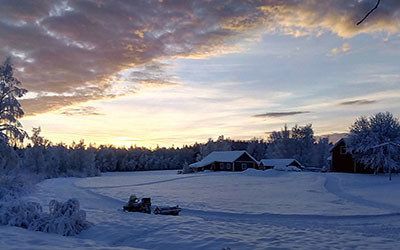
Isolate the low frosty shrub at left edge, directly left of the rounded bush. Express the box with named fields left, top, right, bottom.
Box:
left=0, top=200, right=42, bottom=228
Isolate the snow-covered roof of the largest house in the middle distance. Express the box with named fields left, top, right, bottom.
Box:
left=189, top=150, right=257, bottom=168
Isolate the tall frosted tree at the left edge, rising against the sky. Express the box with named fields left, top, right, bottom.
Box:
left=0, top=58, right=27, bottom=143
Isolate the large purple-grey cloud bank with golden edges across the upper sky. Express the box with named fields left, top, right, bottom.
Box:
left=0, top=0, right=400, bottom=114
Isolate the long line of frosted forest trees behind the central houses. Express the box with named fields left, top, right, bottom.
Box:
left=0, top=125, right=330, bottom=178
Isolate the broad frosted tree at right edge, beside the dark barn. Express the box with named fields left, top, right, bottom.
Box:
left=348, top=112, right=400, bottom=179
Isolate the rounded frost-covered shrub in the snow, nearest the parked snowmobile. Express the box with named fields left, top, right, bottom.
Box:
left=29, top=199, right=90, bottom=236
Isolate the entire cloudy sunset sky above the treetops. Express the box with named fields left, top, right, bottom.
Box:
left=0, top=0, right=400, bottom=147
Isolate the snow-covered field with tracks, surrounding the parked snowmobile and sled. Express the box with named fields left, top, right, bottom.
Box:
left=0, top=169, right=400, bottom=249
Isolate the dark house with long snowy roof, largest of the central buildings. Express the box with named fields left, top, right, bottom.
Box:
left=189, top=151, right=258, bottom=172
